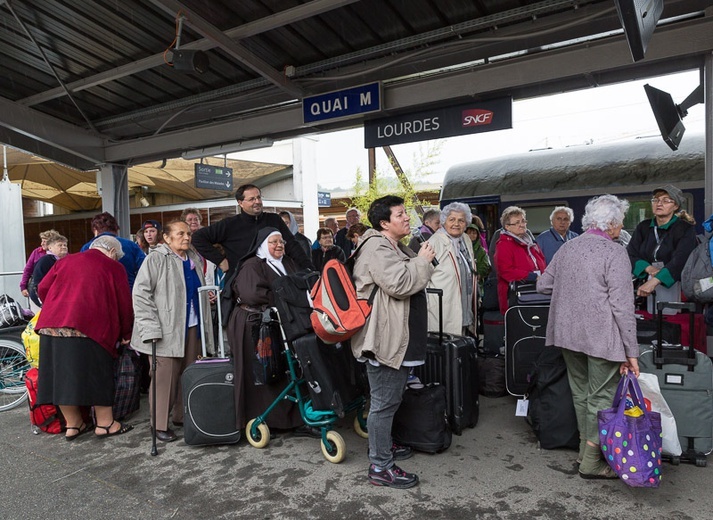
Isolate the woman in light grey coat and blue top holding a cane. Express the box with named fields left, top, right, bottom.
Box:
left=131, top=220, right=213, bottom=442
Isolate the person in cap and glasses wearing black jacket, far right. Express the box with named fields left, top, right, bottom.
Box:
left=627, top=184, right=697, bottom=297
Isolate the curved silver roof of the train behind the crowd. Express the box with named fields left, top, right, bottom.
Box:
left=441, top=133, right=705, bottom=201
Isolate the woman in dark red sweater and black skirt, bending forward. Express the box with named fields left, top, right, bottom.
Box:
left=36, top=235, right=134, bottom=441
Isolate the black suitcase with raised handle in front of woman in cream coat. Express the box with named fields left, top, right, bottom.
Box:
left=415, top=289, right=480, bottom=435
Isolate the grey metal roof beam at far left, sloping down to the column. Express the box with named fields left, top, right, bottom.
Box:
left=0, top=98, right=104, bottom=165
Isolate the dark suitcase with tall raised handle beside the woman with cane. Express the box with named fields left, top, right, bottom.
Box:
left=181, top=286, right=240, bottom=446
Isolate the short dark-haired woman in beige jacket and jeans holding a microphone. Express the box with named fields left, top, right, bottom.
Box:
left=352, top=195, right=435, bottom=489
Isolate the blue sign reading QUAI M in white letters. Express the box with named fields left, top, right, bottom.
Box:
left=302, top=81, right=381, bottom=123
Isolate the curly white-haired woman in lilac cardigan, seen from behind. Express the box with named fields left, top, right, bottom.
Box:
left=537, top=195, right=639, bottom=479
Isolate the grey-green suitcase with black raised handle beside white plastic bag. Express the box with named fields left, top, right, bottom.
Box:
left=639, top=302, right=713, bottom=466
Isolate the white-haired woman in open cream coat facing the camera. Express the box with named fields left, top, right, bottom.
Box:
left=428, top=202, right=476, bottom=335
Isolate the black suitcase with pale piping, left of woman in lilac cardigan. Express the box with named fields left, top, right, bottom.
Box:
left=505, top=305, right=550, bottom=396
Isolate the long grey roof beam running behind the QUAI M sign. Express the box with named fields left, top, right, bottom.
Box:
left=106, top=14, right=713, bottom=162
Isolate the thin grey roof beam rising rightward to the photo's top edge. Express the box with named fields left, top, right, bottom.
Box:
left=20, top=0, right=359, bottom=106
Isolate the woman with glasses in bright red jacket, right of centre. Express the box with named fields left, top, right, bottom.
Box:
left=495, top=206, right=547, bottom=315
